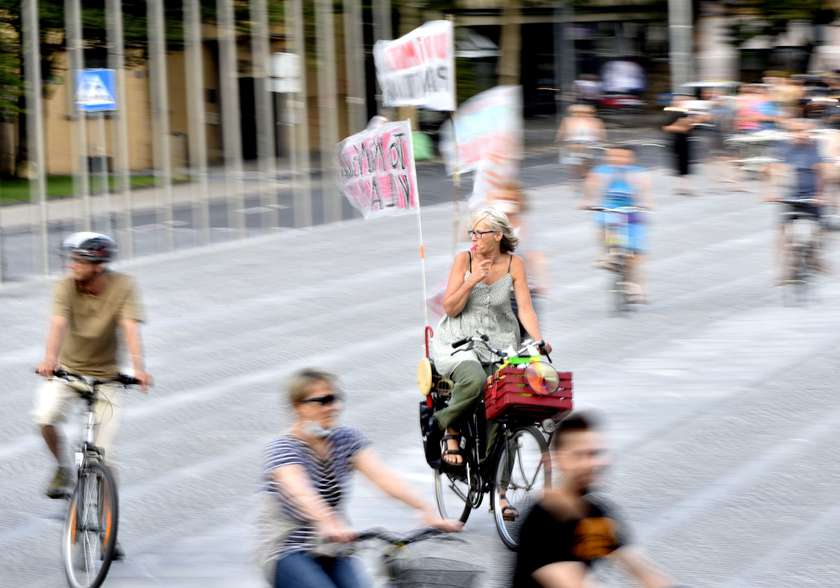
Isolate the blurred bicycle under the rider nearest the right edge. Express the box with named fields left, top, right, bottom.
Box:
left=778, top=199, right=821, bottom=304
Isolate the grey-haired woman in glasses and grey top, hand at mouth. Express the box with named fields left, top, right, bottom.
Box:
left=431, top=208, right=551, bottom=476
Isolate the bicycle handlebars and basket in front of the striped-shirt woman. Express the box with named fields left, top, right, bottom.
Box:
left=314, top=527, right=483, bottom=588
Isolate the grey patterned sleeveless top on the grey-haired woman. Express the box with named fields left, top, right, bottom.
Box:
left=432, top=250, right=519, bottom=376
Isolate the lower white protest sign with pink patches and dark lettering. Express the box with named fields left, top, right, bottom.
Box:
left=338, top=120, right=420, bottom=218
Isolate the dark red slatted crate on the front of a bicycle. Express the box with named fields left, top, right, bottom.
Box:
left=484, top=366, right=572, bottom=420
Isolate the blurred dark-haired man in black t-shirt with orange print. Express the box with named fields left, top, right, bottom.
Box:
left=513, top=413, right=675, bottom=588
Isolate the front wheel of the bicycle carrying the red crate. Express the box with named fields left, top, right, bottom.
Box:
left=493, top=427, right=551, bottom=549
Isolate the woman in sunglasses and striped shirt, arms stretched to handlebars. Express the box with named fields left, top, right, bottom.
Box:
left=258, top=369, right=461, bottom=588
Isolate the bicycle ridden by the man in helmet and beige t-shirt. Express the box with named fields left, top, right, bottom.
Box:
left=53, top=370, right=140, bottom=588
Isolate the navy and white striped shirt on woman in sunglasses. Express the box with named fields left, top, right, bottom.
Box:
left=263, top=427, right=369, bottom=560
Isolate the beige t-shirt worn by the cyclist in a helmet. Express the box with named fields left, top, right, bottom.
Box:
left=53, top=272, right=143, bottom=378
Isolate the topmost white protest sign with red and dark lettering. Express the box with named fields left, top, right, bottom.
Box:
left=373, top=20, right=456, bottom=112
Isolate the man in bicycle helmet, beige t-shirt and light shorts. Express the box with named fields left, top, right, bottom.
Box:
left=33, top=232, right=152, bottom=508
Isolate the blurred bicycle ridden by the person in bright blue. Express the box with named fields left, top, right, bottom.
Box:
left=589, top=206, right=645, bottom=314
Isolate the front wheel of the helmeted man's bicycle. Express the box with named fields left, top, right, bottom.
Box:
left=62, top=463, right=119, bottom=588
